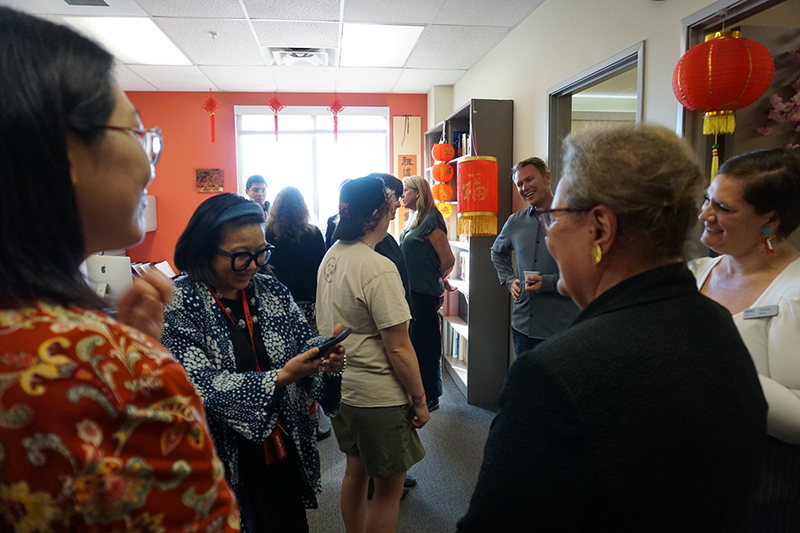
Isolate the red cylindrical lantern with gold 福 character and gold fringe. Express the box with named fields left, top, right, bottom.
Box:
left=457, top=156, right=497, bottom=236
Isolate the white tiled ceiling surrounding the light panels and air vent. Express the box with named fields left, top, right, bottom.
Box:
left=0, top=0, right=544, bottom=93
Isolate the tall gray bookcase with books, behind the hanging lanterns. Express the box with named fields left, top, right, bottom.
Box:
left=425, top=99, right=514, bottom=405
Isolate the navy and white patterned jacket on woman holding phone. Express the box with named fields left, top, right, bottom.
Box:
left=162, top=274, right=341, bottom=520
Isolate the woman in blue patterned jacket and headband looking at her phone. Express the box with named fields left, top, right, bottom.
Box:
left=163, top=193, right=346, bottom=532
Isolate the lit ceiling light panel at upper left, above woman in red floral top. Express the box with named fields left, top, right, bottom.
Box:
left=63, top=17, right=192, bottom=65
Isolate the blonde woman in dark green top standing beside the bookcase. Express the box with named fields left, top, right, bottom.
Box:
left=400, top=176, right=456, bottom=411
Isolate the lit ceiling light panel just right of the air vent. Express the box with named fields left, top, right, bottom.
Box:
left=339, top=24, right=425, bottom=67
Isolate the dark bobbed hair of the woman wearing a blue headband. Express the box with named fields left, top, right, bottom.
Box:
left=174, top=192, right=264, bottom=285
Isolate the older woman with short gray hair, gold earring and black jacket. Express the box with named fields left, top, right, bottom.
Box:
left=458, top=126, right=766, bottom=532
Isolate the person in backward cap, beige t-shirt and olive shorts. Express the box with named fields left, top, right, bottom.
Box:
left=317, top=176, right=430, bottom=533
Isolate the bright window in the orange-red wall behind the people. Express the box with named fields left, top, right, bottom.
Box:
left=234, top=106, right=389, bottom=226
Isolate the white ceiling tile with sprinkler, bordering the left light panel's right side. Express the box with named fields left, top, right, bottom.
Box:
left=154, top=18, right=266, bottom=65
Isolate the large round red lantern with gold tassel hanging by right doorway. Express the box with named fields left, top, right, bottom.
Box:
left=672, top=31, right=775, bottom=179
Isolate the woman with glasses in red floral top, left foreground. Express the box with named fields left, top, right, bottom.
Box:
left=0, top=7, right=238, bottom=531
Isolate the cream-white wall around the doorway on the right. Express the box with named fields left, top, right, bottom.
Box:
left=453, top=0, right=713, bottom=202
